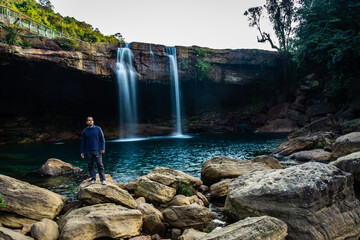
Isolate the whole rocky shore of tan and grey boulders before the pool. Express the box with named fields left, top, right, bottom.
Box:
left=0, top=115, right=360, bottom=240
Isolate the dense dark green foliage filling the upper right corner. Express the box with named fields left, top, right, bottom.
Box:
left=295, top=0, right=360, bottom=100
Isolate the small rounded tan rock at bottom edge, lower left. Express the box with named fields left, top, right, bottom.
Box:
left=31, top=219, right=60, bottom=240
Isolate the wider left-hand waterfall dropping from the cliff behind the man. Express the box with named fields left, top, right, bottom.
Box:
left=115, top=44, right=138, bottom=138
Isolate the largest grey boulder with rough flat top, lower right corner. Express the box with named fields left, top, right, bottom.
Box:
left=224, top=162, right=360, bottom=240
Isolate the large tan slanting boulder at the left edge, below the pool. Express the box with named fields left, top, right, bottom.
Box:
left=0, top=174, right=64, bottom=220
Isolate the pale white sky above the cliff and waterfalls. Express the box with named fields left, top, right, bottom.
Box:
left=51, top=0, right=274, bottom=50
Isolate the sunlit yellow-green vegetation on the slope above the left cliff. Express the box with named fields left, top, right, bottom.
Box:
left=0, top=0, right=124, bottom=42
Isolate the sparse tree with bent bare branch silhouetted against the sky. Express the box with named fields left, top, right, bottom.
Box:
left=244, top=0, right=295, bottom=51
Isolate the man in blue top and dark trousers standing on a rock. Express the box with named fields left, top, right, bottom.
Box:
left=80, top=117, right=106, bottom=185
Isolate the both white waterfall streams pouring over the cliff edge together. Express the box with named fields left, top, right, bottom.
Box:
left=115, top=44, right=185, bottom=141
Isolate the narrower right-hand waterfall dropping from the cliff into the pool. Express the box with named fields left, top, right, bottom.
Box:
left=166, top=47, right=182, bottom=136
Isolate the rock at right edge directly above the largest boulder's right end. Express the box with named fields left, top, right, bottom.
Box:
left=330, top=152, right=360, bottom=183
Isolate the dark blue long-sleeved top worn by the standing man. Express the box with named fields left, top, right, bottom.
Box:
left=80, top=125, right=105, bottom=153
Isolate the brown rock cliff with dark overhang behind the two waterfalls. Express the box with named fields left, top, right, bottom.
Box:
left=0, top=34, right=282, bottom=142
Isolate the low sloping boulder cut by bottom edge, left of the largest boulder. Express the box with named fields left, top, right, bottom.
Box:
left=199, top=216, right=287, bottom=240
